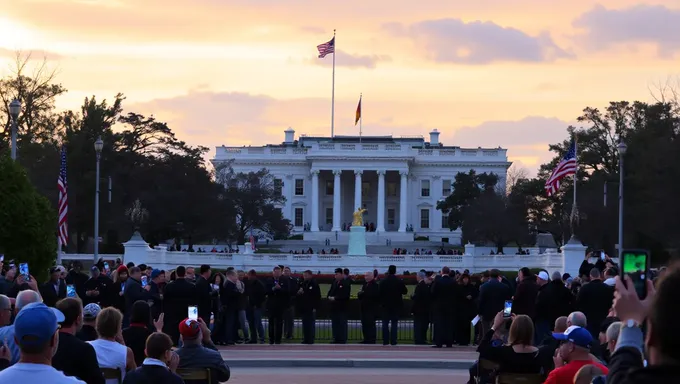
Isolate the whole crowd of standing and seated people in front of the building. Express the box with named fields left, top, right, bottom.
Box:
left=0, top=252, right=680, bottom=384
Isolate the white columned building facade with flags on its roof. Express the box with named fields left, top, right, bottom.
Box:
left=213, top=128, right=511, bottom=244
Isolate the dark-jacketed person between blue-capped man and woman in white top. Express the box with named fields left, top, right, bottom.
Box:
left=52, top=297, right=104, bottom=384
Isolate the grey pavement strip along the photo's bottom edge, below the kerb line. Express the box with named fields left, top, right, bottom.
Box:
left=228, top=368, right=469, bottom=384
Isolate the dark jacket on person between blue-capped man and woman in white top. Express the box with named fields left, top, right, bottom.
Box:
left=52, top=332, right=104, bottom=384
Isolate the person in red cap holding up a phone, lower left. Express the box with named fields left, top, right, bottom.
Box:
left=176, top=319, right=231, bottom=384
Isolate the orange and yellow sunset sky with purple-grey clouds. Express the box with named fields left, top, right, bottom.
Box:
left=0, top=0, right=680, bottom=173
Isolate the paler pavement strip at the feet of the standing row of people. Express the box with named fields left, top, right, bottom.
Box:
left=219, top=344, right=477, bottom=370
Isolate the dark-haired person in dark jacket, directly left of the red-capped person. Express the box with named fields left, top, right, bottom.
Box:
left=123, top=332, right=184, bottom=384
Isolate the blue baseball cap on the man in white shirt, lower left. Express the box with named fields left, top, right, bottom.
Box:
left=14, top=303, right=64, bottom=346
